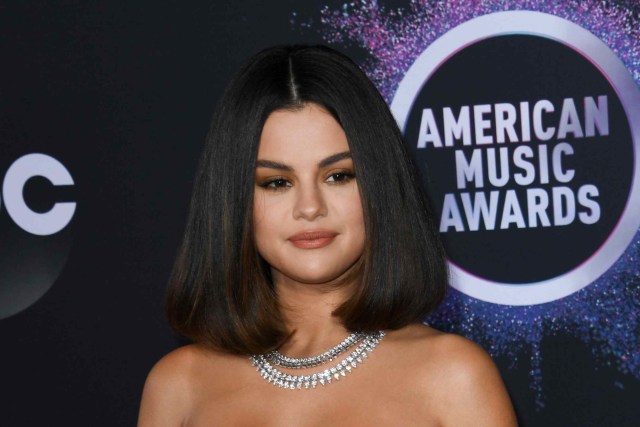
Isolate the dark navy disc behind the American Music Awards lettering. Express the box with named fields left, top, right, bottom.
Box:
left=405, top=35, right=634, bottom=284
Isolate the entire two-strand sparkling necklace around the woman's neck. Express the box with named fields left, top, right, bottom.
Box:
left=250, top=331, right=384, bottom=390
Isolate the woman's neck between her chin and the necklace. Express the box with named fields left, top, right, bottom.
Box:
left=274, top=274, right=352, bottom=357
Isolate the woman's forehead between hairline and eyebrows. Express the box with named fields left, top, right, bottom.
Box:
left=258, top=104, right=349, bottom=164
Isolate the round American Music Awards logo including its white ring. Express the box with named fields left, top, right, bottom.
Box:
left=391, top=11, right=640, bottom=305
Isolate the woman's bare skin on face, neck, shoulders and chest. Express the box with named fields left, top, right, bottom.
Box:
left=138, top=105, right=516, bottom=427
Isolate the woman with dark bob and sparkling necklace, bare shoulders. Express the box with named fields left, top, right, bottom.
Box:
left=139, top=46, right=515, bottom=427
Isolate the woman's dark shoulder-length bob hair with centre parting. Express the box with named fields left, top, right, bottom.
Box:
left=167, top=46, right=448, bottom=354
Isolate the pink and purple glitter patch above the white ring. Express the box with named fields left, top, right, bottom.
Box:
left=306, top=0, right=640, bottom=103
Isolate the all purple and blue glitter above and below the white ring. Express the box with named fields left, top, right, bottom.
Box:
left=300, top=0, right=640, bottom=407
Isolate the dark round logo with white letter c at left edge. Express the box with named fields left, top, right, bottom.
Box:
left=0, top=149, right=75, bottom=319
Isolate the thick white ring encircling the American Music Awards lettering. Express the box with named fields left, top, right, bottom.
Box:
left=391, top=11, right=640, bottom=305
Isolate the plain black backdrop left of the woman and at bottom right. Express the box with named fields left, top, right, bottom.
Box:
left=0, top=1, right=640, bottom=426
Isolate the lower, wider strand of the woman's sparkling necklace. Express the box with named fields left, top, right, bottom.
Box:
left=250, top=331, right=384, bottom=390
